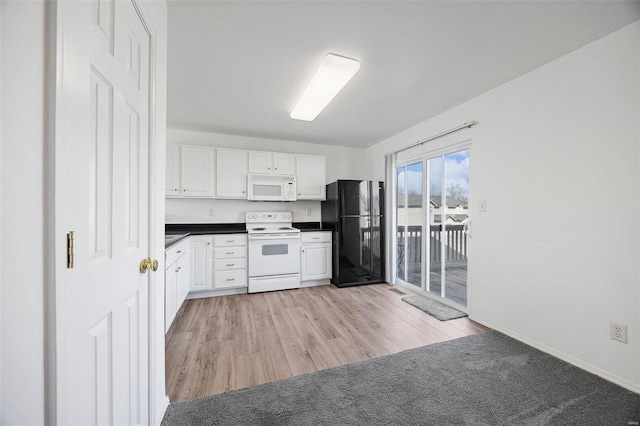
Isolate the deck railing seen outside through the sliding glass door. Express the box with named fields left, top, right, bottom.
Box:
left=398, top=225, right=467, bottom=270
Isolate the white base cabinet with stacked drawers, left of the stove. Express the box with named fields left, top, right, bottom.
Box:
left=212, top=234, right=247, bottom=290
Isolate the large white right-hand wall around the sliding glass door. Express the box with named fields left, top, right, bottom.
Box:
left=367, top=21, right=640, bottom=392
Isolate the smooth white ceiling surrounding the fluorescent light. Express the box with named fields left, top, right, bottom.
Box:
left=168, top=0, right=640, bottom=147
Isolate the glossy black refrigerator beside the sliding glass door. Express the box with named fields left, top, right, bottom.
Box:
left=321, top=180, right=385, bottom=287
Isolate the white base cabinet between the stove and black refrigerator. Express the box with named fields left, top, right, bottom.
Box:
left=300, top=232, right=331, bottom=282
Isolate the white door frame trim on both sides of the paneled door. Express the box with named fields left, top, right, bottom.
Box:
left=43, top=0, right=162, bottom=424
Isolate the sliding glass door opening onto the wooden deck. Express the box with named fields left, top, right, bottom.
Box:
left=396, top=149, right=469, bottom=306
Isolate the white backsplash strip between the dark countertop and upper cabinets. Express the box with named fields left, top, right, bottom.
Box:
left=165, top=198, right=320, bottom=223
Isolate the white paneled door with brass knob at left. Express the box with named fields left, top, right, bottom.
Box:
left=55, top=0, right=150, bottom=425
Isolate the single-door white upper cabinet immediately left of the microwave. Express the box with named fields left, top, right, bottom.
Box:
left=216, top=148, right=247, bottom=199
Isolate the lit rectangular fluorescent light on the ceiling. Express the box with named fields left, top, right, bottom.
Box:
left=289, top=53, right=360, bottom=121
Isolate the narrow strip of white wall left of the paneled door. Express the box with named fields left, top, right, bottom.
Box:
left=0, top=1, right=45, bottom=425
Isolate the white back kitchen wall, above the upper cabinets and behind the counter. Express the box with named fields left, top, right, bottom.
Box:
left=166, top=129, right=369, bottom=223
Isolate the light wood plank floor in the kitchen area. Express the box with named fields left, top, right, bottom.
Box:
left=166, top=284, right=488, bottom=402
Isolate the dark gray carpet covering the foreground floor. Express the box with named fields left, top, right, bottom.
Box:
left=162, top=331, right=640, bottom=426
